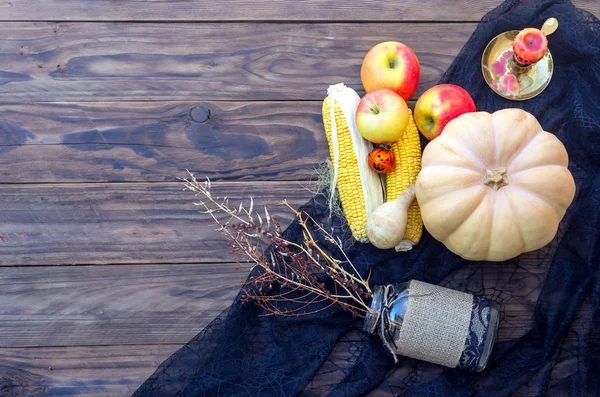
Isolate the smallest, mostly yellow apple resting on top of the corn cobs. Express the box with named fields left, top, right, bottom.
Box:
left=356, top=89, right=408, bottom=143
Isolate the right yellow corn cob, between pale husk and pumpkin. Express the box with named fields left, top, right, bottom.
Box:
left=386, top=110, right=423, bottom=251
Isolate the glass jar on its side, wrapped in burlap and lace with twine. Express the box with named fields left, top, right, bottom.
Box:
left=363, top=280, right=499, bottom=372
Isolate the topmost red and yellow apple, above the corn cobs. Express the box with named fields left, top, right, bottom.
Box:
left=360, top=41, right=421, bottom=101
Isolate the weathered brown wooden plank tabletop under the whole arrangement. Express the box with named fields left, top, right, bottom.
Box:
left=0, top=0, right=600, bottom=396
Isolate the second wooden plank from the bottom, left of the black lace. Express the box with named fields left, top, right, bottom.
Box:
left=0, top=263, right=248, bottom=346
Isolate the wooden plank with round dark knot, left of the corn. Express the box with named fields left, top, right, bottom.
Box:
left=0, top=101, right=329, bottom=183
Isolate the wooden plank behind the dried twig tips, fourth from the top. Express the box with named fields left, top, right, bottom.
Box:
left=0, top=182, right=312, bottom=266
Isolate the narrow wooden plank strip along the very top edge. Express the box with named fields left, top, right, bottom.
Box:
left=0, top=0, right=600, bottom=22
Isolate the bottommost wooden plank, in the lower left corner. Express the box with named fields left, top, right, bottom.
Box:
left=0, top=345, right=180, bottom=397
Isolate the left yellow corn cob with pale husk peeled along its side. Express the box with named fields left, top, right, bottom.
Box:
left=323, top=84, right=383, bottom=242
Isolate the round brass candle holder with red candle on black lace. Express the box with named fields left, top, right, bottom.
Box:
left=481, top=18, right=558, bottom=101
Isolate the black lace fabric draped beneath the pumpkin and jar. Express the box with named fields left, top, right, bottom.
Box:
left=134, top=0, right=600, bottom=397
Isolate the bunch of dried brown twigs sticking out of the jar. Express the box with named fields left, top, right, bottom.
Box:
left=183, top=173, right=372, bottom=318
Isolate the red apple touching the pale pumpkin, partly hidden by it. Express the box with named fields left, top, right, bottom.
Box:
left=415, top=84, right=475, bottom=140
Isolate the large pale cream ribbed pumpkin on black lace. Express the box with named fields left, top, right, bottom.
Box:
left=416, top=109, right=575, bottom=261
